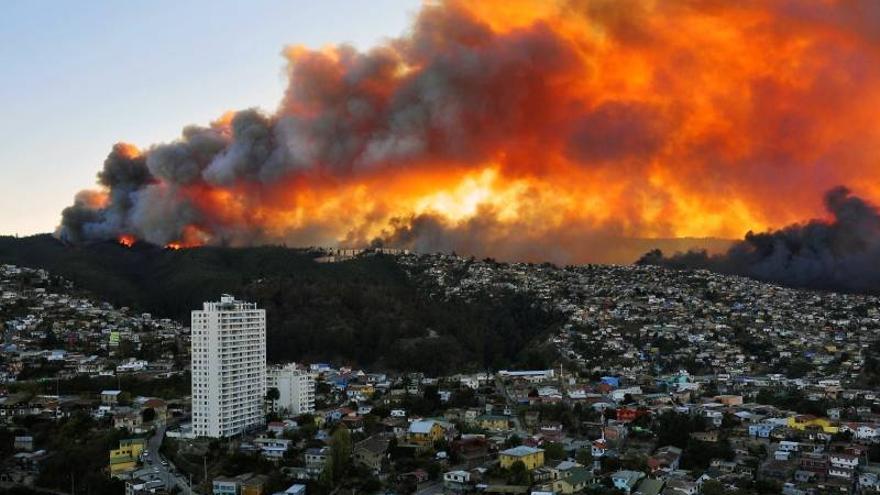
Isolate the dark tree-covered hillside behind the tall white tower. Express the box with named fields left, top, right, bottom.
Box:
left=0, top=235, right=561, bottom=373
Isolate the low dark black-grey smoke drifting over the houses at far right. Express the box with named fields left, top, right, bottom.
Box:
left=639, top=187, right=880, bottom=292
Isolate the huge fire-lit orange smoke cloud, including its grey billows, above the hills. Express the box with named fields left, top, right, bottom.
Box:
left=58, top=0, right=880, bottom=268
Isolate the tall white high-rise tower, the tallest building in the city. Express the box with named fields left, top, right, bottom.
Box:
left=191, top=294, right=266, bottom=438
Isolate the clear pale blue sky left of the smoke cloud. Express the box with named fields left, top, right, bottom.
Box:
left=0, top=0, right=420, bottom=235
